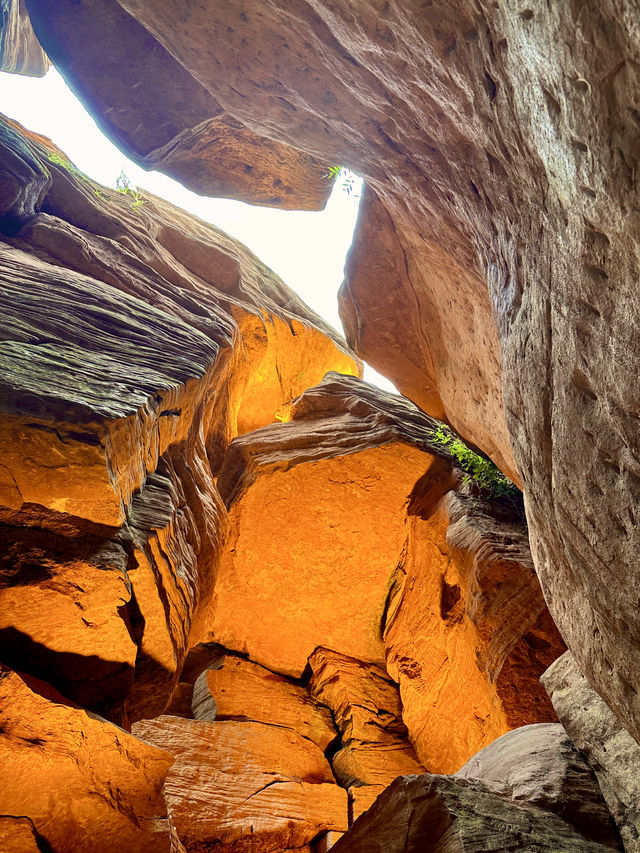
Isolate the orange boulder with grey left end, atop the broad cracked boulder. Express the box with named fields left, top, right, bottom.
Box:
left=192, top=655, right=338, bottom=752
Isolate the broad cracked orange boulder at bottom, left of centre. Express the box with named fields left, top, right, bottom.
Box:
left=133, top=716, right=347, bottom=853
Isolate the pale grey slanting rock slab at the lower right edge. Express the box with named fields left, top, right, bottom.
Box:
left=542, top=652, right=640, bottom=853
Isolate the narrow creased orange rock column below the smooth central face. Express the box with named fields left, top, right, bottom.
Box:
left=309, top=648, right=424, bottom=793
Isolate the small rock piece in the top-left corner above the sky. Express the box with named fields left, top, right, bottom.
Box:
left=0, top=0, right=49, bottom=77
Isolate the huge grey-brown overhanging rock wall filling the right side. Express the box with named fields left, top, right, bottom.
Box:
left=28, top=0, right=640, bottom=739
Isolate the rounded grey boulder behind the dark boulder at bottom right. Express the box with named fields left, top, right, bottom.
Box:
left=456, top=723, right=620, bottom=850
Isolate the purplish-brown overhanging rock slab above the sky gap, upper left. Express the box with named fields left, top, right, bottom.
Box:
left=26, top=0, right=331, bottom=210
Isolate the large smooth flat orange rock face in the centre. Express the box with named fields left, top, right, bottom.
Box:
left=211, top=440, right=429, bottom=677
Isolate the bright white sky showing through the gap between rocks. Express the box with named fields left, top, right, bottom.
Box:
left=0, top=68, right=395, bottom=391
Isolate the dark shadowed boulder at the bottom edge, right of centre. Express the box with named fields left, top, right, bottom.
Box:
left=333, top=775, right=612, bottom=853
